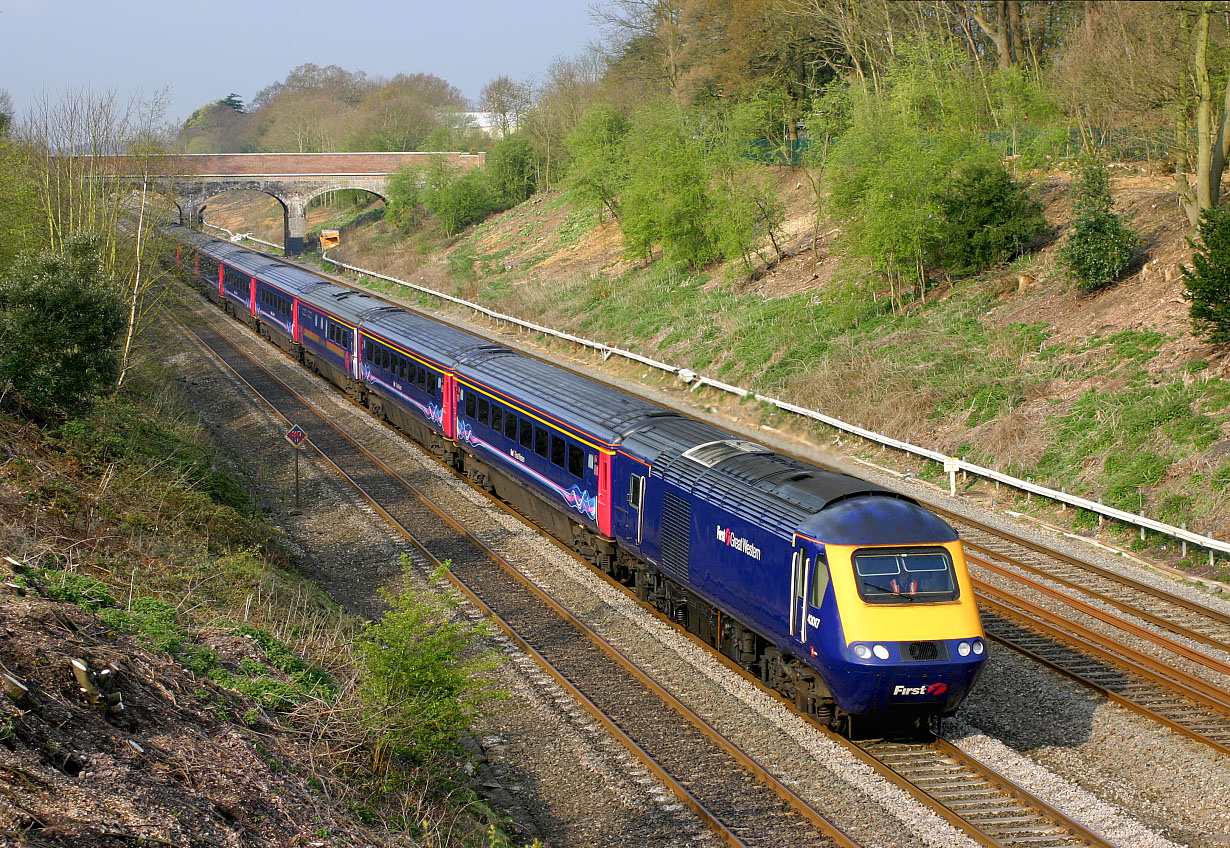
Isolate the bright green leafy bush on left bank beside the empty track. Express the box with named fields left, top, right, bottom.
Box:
left=357, top=559, right=496, bottom=763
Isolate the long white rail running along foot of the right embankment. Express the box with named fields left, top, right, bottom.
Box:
left=194, top=224, right=1230, bottom=564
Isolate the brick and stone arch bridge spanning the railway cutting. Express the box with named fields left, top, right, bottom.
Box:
left=105, top=153, right=486, bottom=256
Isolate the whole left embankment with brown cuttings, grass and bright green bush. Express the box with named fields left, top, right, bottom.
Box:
left=0, top=334, right=506, bottom=846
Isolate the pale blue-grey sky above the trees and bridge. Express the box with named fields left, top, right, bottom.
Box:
left=0, top=0, right=600, bottom=123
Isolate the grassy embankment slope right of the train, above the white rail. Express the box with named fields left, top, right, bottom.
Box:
left=319, top=188, right=1230, bottom=580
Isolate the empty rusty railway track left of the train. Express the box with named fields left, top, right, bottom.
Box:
left=179, top=311, right=857, bottom=848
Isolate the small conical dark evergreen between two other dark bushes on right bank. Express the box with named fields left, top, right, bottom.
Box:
left=1059, top=159, right=1140, bottom=292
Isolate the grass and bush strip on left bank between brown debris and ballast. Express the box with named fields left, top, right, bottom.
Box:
left=0, top=322, right=506, bottom=846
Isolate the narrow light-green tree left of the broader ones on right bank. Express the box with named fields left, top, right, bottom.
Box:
left=565, top=103, right=631, bottom=218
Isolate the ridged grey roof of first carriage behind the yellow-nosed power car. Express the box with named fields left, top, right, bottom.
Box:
left=456, top=345, right=674, bottom=444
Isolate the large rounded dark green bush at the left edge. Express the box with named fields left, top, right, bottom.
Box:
left=0, top=236, right=128, bottom=415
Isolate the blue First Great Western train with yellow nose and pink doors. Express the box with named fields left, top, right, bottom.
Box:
left=171, top=228, right=986, bottom=732
